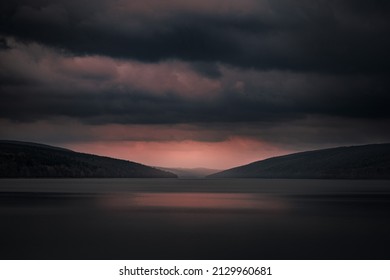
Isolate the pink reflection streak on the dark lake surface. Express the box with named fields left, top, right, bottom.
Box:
left=100, top=192, right=286, bottom=210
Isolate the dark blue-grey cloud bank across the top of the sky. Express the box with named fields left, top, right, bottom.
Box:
left=0, top=0, right=390, bottom=73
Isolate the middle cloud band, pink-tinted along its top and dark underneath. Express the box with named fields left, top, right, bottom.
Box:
left=0, top=36, right=390, bottom=128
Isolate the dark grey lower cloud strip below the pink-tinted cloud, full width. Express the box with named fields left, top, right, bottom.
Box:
left=0, top=69, right=390, bottom=124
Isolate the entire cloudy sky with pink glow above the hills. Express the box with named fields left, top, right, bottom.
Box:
left=0, top=0, right=390, bottom=169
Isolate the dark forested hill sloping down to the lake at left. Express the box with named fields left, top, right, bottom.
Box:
left=0, top=141, right=177, bottom=178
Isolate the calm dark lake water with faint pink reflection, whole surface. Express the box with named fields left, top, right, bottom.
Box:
left=0, top=179, right=390, bottom=259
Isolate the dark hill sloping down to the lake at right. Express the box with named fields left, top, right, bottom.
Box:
left=207, top=143, right=390, bottom=179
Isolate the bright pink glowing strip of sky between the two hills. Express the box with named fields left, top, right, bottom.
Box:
left=67, top=138, right=288, bottom=169
